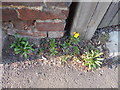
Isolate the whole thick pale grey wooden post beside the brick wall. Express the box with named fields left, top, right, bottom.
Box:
left=71, top=0, right=112, bottom=40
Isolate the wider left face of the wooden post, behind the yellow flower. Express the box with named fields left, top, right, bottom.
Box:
left=71, top=2, right=97, bottom=38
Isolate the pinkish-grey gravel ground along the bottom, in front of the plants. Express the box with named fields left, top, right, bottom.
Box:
left=2, top=62, right=118, bottom=88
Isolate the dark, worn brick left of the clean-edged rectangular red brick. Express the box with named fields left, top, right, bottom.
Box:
left=12, top=20, right=34, bottom=30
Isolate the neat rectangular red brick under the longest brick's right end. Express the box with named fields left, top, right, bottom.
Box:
left=36, top=22, right=65, bottom=31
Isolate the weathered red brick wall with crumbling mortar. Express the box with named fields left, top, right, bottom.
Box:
left=2, top=2, right=71, bottom=38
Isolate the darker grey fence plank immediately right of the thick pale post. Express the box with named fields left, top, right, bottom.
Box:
left=98, top=2, right=118, bottom=28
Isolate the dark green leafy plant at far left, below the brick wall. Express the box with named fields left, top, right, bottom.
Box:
left=10, top=34, right=34, bottom=58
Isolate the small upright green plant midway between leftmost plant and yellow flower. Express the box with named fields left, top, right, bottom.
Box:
left=50, top=39, right=58, bottom=55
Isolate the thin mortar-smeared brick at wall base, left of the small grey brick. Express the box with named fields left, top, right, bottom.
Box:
left=17, top=30, right=47, bottom=38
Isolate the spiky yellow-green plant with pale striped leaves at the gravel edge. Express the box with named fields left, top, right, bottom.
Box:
left=82, top=50, right=103, bottom=70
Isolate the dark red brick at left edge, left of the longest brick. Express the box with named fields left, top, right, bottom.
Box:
left=2, top=9, right=18, bottom=21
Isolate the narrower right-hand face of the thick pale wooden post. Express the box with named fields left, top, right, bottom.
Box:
left=84, top=0, right=112, bottom=40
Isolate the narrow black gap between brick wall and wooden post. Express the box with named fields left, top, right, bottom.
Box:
left=65, top=2, right=78, bottom=36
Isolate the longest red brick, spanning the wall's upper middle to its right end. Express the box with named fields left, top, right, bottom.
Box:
left=17, top=9, right=67, bottom=20
